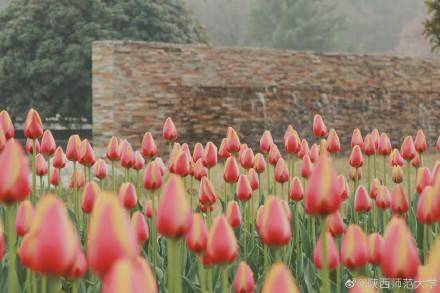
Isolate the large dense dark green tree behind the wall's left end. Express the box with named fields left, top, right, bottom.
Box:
left=0, top=0, right=205, bottom=119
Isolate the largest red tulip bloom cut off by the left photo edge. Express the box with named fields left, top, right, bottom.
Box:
left=0, top=139, right=31, bottom=204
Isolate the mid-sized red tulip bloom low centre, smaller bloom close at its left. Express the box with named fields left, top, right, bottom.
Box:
left=206, top=215, right=238, bottom=264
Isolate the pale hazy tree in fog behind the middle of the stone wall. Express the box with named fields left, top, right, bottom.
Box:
left=250, top=0, right=341, bottom=51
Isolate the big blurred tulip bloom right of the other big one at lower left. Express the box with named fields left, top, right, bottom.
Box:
left=86, top=193, right=139, bottom=277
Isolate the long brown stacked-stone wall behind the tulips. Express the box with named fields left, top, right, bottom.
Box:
left=92, top=41, right=440, bottom=155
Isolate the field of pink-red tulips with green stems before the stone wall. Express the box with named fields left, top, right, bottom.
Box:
left=0, top=109, right=440, bottom=293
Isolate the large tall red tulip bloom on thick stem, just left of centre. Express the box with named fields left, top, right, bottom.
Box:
left=157, top=175, right=191, bottom=238
